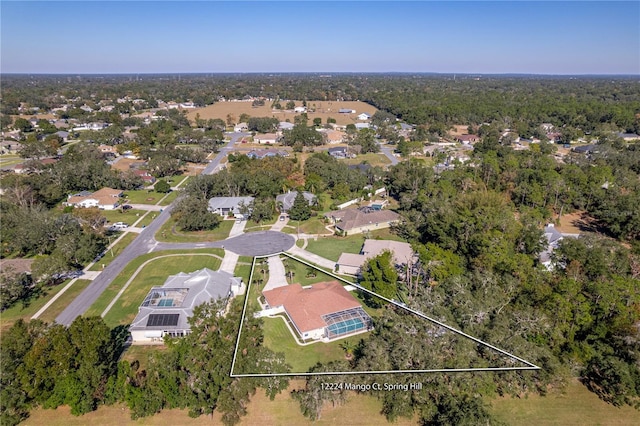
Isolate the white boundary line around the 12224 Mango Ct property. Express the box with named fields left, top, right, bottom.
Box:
left=229, top=252, right=542, bottom=377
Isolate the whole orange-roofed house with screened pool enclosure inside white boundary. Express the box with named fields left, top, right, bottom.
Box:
left=262, top=281, right=373, bottom=341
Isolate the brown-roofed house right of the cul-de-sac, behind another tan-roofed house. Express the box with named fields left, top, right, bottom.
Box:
left=325, top=207, right=400, bottom=235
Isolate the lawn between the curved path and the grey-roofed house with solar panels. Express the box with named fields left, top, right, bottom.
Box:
left=104, top=254, right=221, bottom=327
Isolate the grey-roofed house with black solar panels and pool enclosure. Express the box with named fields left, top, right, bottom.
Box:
left=129, top=268, right=244, bottom=345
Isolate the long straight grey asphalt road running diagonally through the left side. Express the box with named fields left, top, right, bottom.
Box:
left=56, top=133, right=247, bottom=325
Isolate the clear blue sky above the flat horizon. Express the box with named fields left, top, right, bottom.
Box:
left=0, top=0, right=640, bottom=75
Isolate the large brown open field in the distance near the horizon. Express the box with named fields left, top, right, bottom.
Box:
left=187, top=101, right=377, bottom=125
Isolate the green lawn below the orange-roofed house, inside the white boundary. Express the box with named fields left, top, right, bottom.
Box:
left=256, top=318, right=367, bottom=373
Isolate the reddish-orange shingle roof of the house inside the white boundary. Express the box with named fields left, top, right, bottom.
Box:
left=262, top=281, right=361, bottom=333
